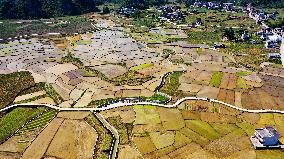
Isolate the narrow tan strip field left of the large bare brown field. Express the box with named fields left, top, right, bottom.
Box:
left=22, top=118, right=63, bottom=159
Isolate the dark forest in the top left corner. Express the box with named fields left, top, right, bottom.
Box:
left=0, top=0, right=98, bottom=19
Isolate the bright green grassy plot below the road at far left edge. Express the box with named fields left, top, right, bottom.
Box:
left=0, top=108, right=45, bottom=142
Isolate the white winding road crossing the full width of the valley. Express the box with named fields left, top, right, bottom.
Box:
left=0, top=97, right=284, bottom=114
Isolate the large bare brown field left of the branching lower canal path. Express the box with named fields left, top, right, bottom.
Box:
left=46, top=120, right=97, bottom=159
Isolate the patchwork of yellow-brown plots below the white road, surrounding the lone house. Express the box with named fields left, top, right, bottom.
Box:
left=103, top=101, right=284, bottom=159
